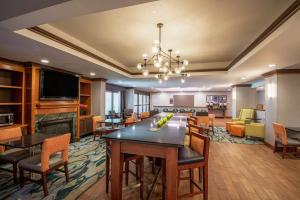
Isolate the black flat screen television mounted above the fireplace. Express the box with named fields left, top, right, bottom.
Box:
left=40, top=69, right=79, bottom=100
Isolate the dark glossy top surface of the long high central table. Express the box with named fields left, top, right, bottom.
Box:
left=102, top=113, right=186, bottom=147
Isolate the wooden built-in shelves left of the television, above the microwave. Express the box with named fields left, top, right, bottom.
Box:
left=0, top=61, right=25, bottom=125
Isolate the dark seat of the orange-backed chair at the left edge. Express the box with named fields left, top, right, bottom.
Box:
left=0, top=148, right=30, bottom=163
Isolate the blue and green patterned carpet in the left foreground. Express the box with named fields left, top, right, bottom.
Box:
left=0, top=136, right=106, bottom=200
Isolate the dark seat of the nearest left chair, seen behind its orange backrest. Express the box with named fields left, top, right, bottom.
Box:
left=19, top=153, right=63, bottom=171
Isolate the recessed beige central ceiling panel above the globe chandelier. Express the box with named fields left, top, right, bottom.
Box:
left=50, top=0, right=292, bottom=70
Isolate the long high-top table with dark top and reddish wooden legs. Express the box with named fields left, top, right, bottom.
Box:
left=102, top=113, right=186, bottom=200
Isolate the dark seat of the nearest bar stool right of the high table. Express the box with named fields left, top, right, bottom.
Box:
left=178, top=147, right=204, bottom=165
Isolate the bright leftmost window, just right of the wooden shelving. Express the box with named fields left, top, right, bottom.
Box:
left=105, top=91, right=121, bottom=115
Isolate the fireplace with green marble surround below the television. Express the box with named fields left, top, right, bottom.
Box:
left=35, top=113, right=77, bottom=141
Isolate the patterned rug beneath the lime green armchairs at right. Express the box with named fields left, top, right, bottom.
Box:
left=210, top=127, right=263, bottom=144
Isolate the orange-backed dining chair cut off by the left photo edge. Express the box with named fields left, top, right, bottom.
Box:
left=0, top=127, right=30, bottom=183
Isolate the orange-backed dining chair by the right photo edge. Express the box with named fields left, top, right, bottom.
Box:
left=273, top=123, right=300, bottom=159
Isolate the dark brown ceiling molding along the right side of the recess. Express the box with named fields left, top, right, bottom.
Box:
left=226, top=0, right=300, bottom=71
